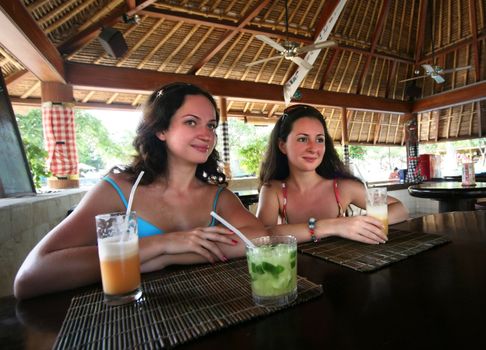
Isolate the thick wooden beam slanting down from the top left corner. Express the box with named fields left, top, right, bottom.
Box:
left=0, top=0, right=65, bottom=83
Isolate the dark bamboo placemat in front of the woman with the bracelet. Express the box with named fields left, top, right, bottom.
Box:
left=298, top=229, right=450, bottom=272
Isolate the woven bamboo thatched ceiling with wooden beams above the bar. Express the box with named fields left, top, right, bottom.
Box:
left=0, top=0, right=486, bottom=145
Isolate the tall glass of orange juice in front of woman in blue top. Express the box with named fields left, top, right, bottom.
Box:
left=96, top=211, right=142, bottom=305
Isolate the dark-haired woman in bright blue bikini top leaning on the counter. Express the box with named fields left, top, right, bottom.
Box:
left=14, top=83, right=268, bottom=299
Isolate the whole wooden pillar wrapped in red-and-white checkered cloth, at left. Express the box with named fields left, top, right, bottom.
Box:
left=41, top=82, right=79, bottom=189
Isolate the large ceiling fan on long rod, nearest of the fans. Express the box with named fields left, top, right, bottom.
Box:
left=246, top=0, right=336, bottom=69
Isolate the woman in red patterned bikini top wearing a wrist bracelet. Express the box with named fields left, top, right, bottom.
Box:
left=257, top=105, right=408, bottom=244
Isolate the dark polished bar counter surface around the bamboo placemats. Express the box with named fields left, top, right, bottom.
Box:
left=0, top=211, right=486, bottom=350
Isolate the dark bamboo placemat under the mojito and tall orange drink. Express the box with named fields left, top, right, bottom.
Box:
left=54, top=259, right=322, bottom=349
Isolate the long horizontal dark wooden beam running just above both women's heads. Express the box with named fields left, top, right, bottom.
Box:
left=66, top=62, right=411, bottom=113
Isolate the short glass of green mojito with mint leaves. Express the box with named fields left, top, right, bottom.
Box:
left=246, top=236, right=297, bottom=306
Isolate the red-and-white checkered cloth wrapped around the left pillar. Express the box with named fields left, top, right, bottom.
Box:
left=42, top=102, right=78, bottom=177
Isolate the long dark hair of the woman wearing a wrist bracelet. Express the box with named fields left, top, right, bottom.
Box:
left=259, top=104, right=359, bottom=187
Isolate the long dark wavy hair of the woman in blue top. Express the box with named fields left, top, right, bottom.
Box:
left=117, top=83, right=227, bottom=185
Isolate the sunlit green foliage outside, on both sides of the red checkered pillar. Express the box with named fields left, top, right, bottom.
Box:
left=16, top=109, right=133, bottom=189
